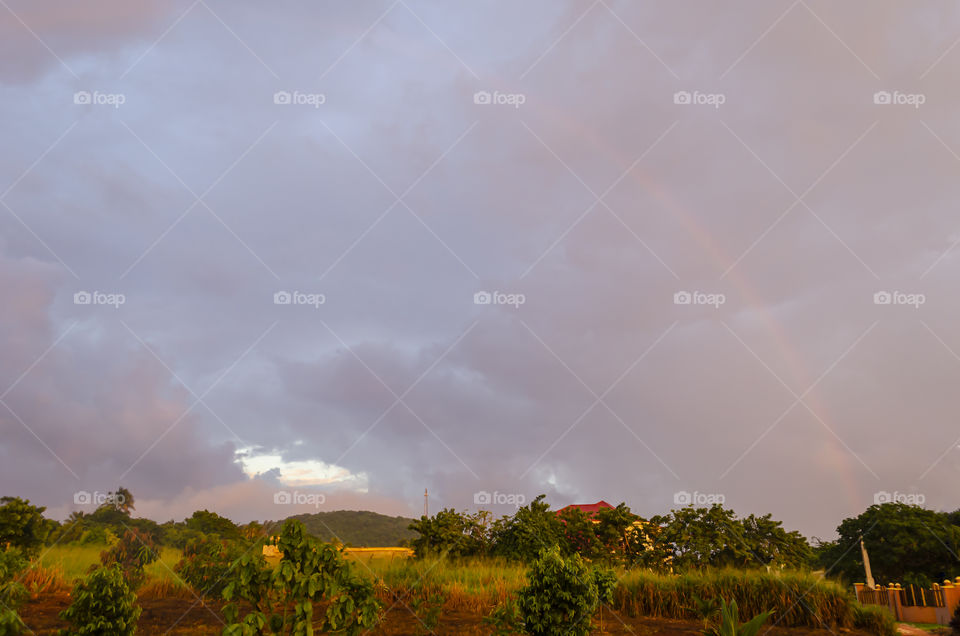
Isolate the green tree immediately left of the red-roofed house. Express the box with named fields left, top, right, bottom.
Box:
left=491, top=495, right=563, bottom=562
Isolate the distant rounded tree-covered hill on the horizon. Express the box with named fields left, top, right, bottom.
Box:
left=290, top=510, right=417, bottom=547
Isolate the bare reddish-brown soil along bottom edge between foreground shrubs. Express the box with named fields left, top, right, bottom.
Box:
left=20, top=594, right=884, bottom=636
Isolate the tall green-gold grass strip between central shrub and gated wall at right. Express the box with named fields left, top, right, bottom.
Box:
left=613, top=570, right=853, bottom=627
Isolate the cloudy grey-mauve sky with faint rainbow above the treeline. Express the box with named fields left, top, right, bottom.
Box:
left=0, top=0, right=960, bottom=539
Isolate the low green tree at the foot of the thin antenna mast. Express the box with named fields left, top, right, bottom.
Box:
left=410, top=508, right=490, bottom=557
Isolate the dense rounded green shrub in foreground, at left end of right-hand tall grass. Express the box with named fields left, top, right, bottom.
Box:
left=517, top=548, right=599, bottom=636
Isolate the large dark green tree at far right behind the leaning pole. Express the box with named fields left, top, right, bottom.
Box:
left=819, top=503, right=960, bottom=583
